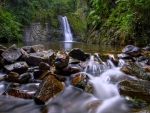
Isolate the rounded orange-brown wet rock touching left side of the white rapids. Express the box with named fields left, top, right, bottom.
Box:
left=71, top=73, right=88, bottom=89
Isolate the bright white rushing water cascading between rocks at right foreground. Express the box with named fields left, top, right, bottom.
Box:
left=85, top=55, right=129, bottom=113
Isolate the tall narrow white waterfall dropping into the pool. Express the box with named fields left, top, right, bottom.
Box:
left=62, top=16, right=73, bottom=42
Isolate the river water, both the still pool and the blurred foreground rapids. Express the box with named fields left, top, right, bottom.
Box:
left=0, top=42, right=145, bottom=113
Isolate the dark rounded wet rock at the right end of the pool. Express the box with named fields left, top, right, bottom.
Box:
left=122, top=45, right=141, bottom=57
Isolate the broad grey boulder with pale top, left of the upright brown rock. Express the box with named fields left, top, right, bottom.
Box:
left=22, top=50, right=54, bottom=66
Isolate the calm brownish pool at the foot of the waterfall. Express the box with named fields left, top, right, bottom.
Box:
left=2, top=42, right=123, bottom=53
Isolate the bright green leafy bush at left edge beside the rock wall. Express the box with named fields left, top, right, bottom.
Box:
left=0, top=7, right=21, bottom=42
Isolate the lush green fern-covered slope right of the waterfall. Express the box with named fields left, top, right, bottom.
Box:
left=86, top=0, right=150, bottom=45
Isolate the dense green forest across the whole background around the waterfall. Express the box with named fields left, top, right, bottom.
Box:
left=0, top=0, right=150, bottom=46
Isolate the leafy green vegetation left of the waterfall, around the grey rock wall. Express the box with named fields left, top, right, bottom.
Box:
left=0, top=0, right=75, bottom=41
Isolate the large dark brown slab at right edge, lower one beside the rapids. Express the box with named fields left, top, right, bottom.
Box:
left=118, top=80, right=150, bottom=103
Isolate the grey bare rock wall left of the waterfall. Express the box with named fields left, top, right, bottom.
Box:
left=22, top=23, right=57, bottom=42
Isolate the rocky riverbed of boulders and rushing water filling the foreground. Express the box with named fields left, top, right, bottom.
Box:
left=0, top=44, right=150, bottom=113
